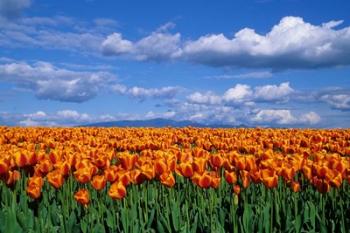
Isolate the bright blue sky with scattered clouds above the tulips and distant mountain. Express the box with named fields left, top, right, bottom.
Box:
left=0, top=0, right=350, bottom=128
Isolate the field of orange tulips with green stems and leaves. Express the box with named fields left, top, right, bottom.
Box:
left=0, top=127, right=350, bottom=233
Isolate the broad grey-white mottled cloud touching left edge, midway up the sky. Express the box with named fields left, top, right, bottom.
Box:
left=0, top=62, right=115, bottom=102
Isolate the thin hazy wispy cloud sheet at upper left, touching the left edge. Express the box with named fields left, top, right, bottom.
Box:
left=0, top=16, right=115, bottom=55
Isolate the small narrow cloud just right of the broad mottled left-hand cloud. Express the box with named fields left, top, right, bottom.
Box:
left=112, top=84, right=180, bottom=100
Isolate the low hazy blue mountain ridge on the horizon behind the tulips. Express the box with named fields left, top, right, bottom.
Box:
left=81, top=118, right=248, bottom=128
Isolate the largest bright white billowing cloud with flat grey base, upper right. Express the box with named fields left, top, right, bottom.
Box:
left=183, top=16, right=350, bottom=70
